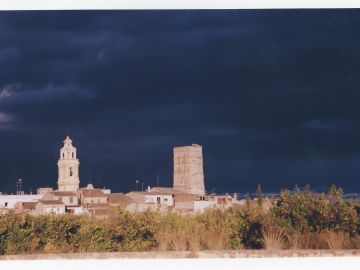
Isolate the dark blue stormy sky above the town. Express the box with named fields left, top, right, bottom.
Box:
left=0, top=10, right=360, bottom=193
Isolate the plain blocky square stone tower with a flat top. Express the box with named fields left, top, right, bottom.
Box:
left=174, top=144, right=205, bottom=195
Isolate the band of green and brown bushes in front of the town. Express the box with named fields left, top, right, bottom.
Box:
left=0, top=186, right=360, bottom=254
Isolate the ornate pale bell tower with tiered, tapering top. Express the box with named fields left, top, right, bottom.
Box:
left=58, top=136, right=80, bottom=191
